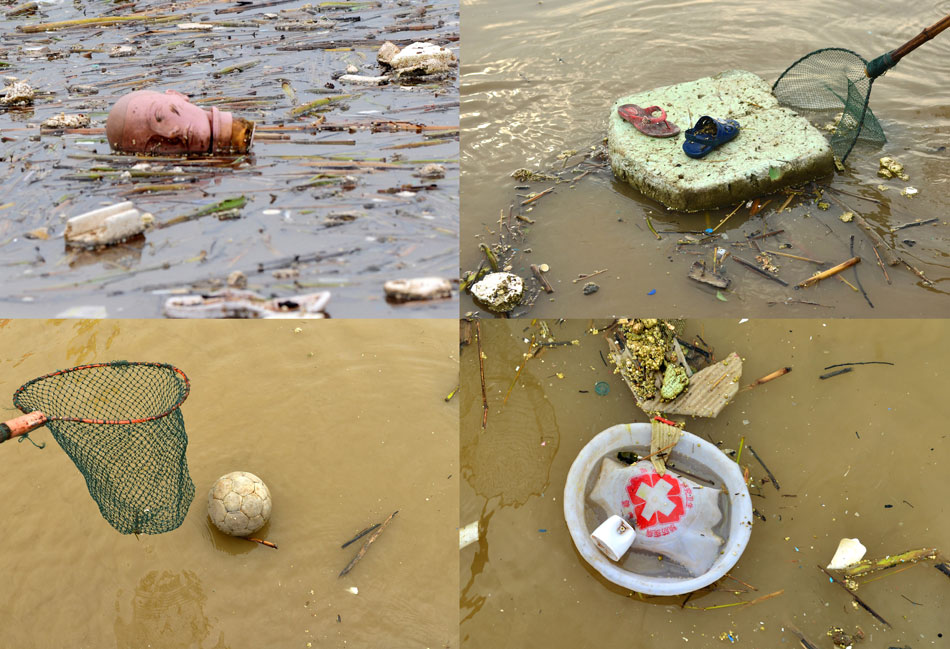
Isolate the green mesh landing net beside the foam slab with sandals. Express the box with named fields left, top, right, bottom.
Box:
left=772, top=47, right=893, bottom=162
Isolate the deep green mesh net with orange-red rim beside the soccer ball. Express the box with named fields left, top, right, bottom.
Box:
left=13, top=361, right=195, bottom=534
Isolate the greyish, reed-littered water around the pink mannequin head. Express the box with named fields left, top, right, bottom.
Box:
left=0, top=0, right=459, bottom=318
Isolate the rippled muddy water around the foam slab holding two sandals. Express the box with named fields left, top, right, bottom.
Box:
left=461, top=0, right=950, bottom=317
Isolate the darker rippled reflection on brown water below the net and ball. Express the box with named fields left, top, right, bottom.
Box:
left=115, top=570, right=229, bottom=649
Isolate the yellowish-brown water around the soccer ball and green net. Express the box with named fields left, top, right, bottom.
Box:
left=0, top=320, right=459, bottom=649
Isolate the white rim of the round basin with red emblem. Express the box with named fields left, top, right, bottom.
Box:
left=564, top=424, right=752, bottom=595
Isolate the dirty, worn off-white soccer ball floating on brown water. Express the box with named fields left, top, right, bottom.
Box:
left=208, top=471, right=271, bottom=536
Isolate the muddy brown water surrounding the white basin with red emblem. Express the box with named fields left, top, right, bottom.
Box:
left=460, top=319, right=950, bottom=649
